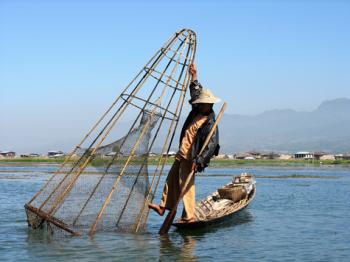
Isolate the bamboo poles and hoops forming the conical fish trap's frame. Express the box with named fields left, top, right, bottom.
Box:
left=25, top=29, right=196, bottom=236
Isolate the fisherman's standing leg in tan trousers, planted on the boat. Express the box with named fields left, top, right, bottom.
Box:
left=180, top=160, right=196, bottom=221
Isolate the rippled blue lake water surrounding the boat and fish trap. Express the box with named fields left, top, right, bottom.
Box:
left=0, top=166, right=350, bottom=261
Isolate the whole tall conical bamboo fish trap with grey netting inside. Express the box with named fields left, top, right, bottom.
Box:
left=25, top=29, right=196, bottom=235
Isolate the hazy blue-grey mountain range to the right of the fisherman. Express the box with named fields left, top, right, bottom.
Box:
left=216, top=98, right=350, bottom=153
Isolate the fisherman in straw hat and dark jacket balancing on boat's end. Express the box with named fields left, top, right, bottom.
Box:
left=148, top=64, right=220, bottom=223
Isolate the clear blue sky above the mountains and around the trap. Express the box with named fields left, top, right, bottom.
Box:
left=0, top=0, right=350, bottom=151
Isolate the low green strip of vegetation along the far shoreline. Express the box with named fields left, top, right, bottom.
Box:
left=0, top=157, right=350, bottom=168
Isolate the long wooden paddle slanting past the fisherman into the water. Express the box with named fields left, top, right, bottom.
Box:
left=158, top=102, right=227, bottom=235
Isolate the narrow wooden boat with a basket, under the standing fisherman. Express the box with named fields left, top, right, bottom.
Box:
left=173, top=173, right=256, bottom=229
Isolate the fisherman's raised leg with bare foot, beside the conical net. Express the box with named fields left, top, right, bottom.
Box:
left=148, top=160, right=180, bottom=216
